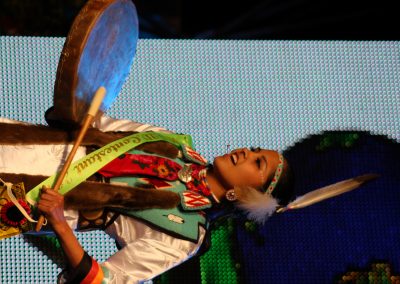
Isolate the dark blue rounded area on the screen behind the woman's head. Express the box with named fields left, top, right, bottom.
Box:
left=237, top=131, right=400, bottom=283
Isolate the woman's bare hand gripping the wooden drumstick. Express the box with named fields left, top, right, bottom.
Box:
left=38, top=187, right=67, bottom=233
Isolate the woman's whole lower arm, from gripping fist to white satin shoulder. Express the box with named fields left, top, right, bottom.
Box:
left=38, top=189, right=205, bottom=283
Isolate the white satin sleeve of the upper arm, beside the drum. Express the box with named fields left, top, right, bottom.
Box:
left=94, top=116, right=172, bottom=133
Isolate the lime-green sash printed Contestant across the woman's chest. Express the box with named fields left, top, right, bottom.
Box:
left=26, top=132, right=192, bottom=205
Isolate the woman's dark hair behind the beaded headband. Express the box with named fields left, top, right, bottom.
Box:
left=265, top=155, right=294, bottom=206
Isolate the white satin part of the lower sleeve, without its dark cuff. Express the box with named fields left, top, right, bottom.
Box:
left=101, top=215, right=205, bottom=283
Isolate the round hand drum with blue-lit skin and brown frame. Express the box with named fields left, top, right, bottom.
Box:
left=50, top=0, right=138, bottom=125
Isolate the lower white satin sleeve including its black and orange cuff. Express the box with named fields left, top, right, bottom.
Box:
left=58, top=224, right=206, bottom=284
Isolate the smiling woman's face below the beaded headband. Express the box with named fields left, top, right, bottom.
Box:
left=214, top=148, right=279, bottom=189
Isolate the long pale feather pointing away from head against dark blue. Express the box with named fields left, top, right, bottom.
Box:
left=277, top=174, right=379, bottom=212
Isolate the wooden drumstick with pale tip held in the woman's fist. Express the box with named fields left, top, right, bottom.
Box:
left=35, top=87, right=106, bottom=232
